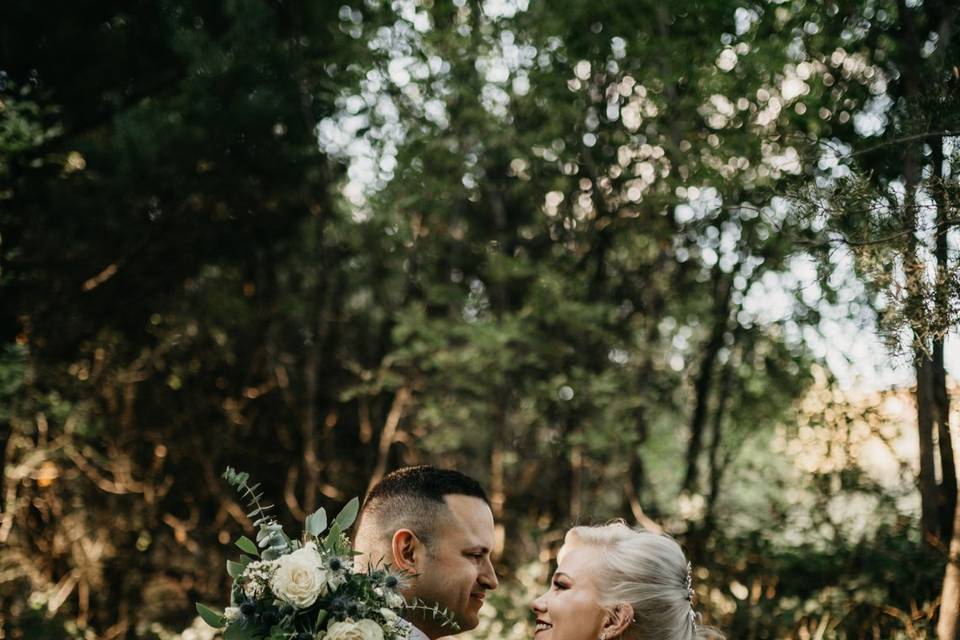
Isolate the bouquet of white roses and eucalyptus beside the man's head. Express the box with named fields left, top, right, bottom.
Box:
left=197, top=467, right=414, bottom=640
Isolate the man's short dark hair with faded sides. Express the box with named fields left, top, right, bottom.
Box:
left=356, top=465, right=490, bottom=545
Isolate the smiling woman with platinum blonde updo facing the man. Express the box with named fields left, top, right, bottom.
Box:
left=531, top=522, right=723, bottom=640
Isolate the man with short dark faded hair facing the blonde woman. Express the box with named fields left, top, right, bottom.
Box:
left=354, top=466, right=497, bottom=640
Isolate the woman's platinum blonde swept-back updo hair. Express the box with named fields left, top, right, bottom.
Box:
left=564, top=521, right=723, bottom=640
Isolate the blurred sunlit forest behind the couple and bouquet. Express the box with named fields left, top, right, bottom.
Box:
left=0, top=0, right=960, bottom=640
